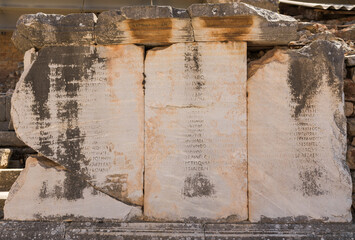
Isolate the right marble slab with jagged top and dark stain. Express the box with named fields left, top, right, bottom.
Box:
left=248, top=41, right=352, bottom=222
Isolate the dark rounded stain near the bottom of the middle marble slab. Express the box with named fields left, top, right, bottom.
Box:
left=182, top=172, right=215, bottom=198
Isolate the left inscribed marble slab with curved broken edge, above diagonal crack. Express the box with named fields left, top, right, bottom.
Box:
left=11, top=45, right=144, bottom=205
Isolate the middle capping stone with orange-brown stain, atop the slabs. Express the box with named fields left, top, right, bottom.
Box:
left=95, top=6, right=194, bottom=45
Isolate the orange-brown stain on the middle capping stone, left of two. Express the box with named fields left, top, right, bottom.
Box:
left=126, top=18, right=173, bottom=43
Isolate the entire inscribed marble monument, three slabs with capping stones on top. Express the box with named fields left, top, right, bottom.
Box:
left=0, top=1, right=355, bottom=238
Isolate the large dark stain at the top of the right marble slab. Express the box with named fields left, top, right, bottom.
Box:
left=288, top=41, right=344, bottom=119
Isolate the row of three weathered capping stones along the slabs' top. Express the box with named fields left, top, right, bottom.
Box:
left=12, top=3, right=297, bottom=51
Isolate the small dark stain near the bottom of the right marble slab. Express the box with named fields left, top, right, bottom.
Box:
left=299, top=168, right=325, bottom=197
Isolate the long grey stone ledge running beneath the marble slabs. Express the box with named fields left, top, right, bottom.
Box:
left=0, top=221, right=355, bottom=240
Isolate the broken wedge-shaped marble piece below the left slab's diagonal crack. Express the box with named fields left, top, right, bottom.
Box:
left=4, top=157, right=141, bottom=220
